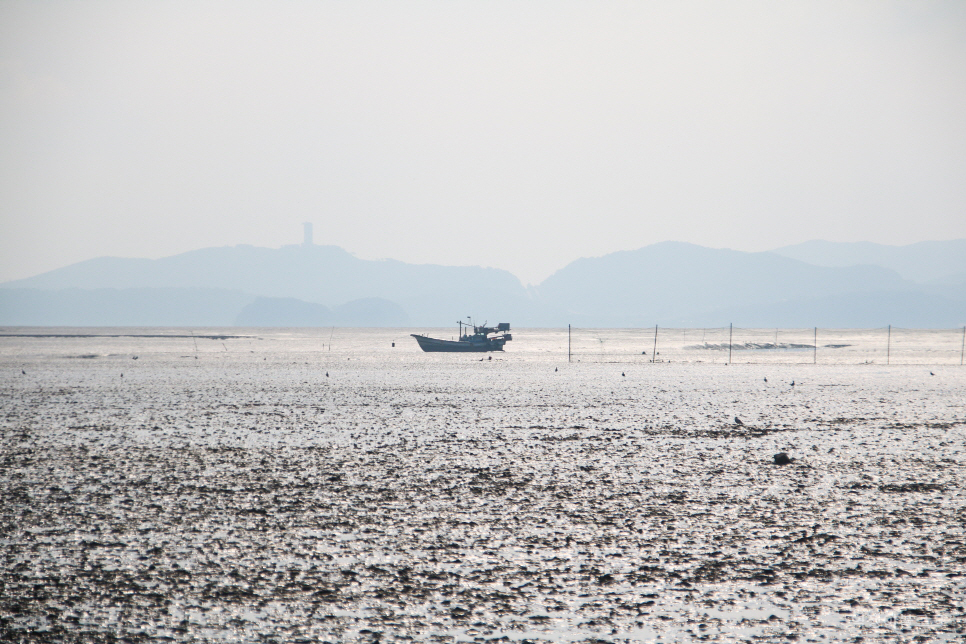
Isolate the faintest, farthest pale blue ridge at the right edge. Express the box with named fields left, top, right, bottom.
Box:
left=772, top=239, right=966, bottom=283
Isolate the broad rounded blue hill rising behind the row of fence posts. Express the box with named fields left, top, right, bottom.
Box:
left=536, top=242, right=966, bottom=327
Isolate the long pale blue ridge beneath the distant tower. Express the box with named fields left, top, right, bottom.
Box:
left=3, top=246, right=528, bottom=326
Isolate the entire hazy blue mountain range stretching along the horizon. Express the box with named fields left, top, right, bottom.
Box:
left=0, top=240, right=966, bottom=328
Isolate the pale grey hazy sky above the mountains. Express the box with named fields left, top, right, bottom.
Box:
left=0, top=0, right=966, bottom=283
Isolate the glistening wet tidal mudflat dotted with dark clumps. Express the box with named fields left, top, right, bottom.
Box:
left=0, top=329, right=966, bottom=643
